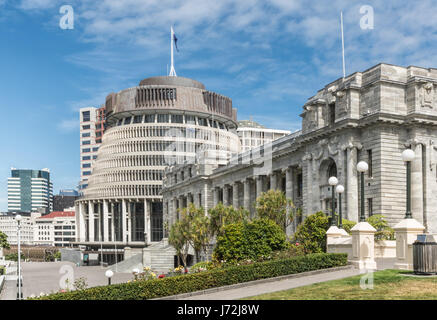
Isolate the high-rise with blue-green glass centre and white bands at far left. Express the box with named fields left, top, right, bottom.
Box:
left=8, top=168, right=53, bottom=213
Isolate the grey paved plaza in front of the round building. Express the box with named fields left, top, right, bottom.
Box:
left=0, top=261, right=133, bottom=300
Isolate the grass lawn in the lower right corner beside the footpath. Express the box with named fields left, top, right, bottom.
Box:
left=244, top=270, right=437, bottom=300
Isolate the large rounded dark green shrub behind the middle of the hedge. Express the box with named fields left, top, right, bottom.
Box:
left=213, top=219, right=288, bottom=264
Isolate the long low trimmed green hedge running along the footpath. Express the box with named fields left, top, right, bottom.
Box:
left=34, top=253, right=347, bottom=300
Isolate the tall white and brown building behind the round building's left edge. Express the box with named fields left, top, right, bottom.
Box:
left=79, top=106, right=105, bottom=193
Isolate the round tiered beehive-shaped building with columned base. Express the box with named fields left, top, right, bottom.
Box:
left=76, top=77, right=240, bottom=263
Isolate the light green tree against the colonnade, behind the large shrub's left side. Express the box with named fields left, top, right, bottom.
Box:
left=208, top=202, right=249, bottom=237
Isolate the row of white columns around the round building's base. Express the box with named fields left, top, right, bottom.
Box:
left=76, top=199, right=151, bottom=243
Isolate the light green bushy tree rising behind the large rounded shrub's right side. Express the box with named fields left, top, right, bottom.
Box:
left=255, top=190, right=296, bottom=232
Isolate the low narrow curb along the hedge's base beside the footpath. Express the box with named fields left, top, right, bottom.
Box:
left=150, top=265, right=354, bottom=300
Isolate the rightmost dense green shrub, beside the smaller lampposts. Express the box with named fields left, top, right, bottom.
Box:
left=294, top=212, right=329, bottom=253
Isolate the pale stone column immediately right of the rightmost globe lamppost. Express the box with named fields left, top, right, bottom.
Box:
left=411, top=144, right=423, bottom=224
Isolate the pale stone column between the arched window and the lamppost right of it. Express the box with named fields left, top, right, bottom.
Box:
left=344, top=147, right=358, bottom=222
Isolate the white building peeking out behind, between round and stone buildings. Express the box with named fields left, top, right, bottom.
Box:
left=237, top=120, right=291, bottom=152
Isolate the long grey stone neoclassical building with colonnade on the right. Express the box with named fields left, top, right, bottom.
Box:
left=162, top=64, right=437, bottom=233
